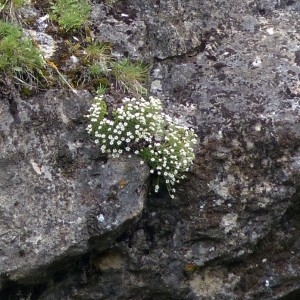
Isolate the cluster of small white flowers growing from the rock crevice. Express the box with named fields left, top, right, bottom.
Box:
left=87, top=96, right=197, bottom=198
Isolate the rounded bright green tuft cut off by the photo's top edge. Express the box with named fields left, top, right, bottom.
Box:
left=50, top=0, right=91, bottom=31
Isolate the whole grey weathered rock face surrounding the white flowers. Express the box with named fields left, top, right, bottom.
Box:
left=0, top=0, right=300, bottom=300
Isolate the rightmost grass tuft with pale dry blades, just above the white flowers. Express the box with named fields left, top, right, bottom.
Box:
left=111, top=58, right=149, bottom=95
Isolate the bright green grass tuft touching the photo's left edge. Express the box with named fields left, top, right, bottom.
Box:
left=0, top=20, right=45, bottom=77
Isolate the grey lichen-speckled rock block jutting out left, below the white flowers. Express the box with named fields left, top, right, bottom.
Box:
left=0, top=91, right=148, bottom=279
